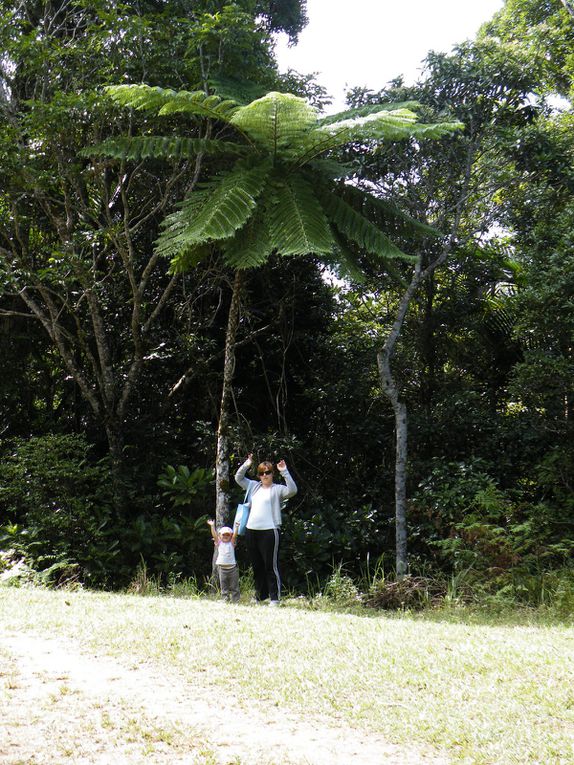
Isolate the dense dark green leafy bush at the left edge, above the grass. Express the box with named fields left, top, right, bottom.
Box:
left=0, top=435, right=118, bottom=586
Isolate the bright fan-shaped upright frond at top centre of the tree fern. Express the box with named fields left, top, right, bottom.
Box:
left=230, top=92, right=317, bottom=156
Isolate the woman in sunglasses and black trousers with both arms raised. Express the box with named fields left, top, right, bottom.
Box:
left=235, top=454, right=297, bottom=606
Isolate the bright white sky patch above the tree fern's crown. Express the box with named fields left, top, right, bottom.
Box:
left=276, top=0, right=504, bottom=111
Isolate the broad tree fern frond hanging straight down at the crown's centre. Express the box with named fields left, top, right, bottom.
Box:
left=267, top=176, right=334, bottom=255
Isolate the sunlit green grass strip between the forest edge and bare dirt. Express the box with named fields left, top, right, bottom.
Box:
left=0, top=588, right=574, bottom=765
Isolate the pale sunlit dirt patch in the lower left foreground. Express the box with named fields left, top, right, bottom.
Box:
left=0, top=633, right=448, bottom=765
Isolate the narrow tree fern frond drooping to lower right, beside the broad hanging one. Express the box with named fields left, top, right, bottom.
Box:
left=321, top=194, right=416, bottom=261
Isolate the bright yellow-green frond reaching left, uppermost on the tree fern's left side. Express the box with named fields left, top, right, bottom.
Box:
left=104, top=84, right=238, bottom=122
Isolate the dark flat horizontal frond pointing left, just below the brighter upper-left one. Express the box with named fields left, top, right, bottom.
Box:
left=80, top=135, right=246, bottom=160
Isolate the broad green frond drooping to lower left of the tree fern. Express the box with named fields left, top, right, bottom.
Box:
left=156, top=163, right=270, bottom=257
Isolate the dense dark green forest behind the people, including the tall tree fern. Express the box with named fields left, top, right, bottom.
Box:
left=0, top=0, right=574, bottom=606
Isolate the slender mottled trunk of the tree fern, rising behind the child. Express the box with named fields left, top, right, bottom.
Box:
left=215, top=270, right=243, bottom=526
